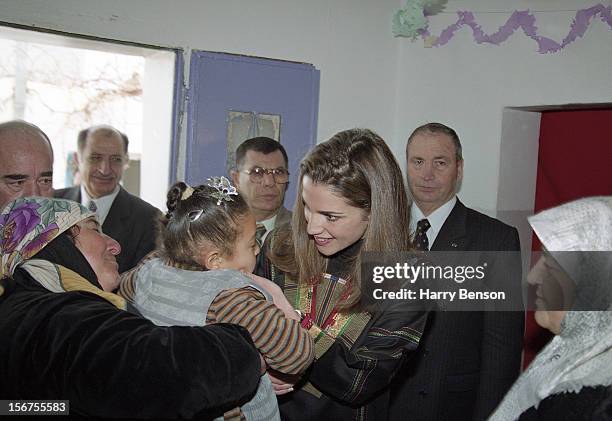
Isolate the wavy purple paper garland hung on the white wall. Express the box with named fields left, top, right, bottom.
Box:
left=421, top=3, right=612, bottom=54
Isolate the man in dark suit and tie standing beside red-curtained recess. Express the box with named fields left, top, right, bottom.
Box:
left=391, top=123, right=524, bottom=421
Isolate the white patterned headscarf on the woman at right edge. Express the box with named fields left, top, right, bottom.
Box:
left=490, top=197, right=612, bottom=421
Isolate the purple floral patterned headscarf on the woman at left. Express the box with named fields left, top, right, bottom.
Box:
left=0, top=197, right=95, bottom=279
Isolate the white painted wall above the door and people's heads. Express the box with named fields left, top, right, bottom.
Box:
left=0, top=0, right=612, bottom=214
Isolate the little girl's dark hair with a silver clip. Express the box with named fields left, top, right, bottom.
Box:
left=159, top=181, right=249, bottom=266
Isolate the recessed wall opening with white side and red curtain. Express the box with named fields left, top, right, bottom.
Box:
left=497, top=103, right=612, bottom=367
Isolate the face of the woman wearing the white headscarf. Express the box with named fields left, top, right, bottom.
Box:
left=527, top=253, right=576, bottom=335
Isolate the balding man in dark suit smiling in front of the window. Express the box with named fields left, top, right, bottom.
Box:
left=55, top=126, right=161, bottom=272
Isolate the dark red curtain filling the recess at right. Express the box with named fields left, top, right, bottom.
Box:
left=524, top=109, right=612, bottom=367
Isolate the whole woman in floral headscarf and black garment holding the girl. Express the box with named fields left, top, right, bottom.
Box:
left=0, top=197, right=262, bottom=418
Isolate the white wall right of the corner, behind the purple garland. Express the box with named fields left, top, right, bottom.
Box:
left=392, top=0, right=612, bottom=215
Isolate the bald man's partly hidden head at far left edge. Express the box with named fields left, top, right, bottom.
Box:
left=0, top=120, right=53, bottom=209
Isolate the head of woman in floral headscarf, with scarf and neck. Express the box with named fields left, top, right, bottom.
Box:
left=0, top=198, right=126, bottom=309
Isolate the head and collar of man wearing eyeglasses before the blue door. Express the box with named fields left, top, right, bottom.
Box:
left=232, top=137, right=291, bottom=273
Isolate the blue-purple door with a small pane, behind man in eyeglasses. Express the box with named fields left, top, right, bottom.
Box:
left=185, top=51, right=319, bottom=209
